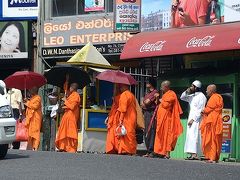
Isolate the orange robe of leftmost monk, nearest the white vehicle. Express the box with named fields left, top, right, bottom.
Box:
left=25, top=95, right=42, bottom=150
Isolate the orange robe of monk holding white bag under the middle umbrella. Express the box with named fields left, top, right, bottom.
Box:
left=115, top=90, right=137, bottom=154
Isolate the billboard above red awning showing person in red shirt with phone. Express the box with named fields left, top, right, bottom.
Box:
left=141, top=0, right=240, bottom=31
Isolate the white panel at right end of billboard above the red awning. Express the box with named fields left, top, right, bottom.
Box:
left=224, top=0, right=240, bottom=22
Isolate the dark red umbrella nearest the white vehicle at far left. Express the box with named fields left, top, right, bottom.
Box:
left=4, top=71, right=47, bottom=90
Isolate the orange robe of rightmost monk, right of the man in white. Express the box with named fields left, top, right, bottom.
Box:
left=200, top=93, right=223, bottom=161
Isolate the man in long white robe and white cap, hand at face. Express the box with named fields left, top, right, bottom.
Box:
left=180, top=80, right=207, bottom=160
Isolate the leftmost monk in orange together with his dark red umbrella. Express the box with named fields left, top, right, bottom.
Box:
left=4, top=71, right=47, bottom=151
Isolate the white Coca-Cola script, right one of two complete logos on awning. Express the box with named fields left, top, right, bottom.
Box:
left=186, top=36, right=215, bottom=48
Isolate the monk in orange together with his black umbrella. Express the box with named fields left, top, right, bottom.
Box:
left=45, top=65, right=91, bottom=153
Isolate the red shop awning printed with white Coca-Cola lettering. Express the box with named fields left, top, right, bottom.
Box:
left=121, top=22, right=240, bottom=59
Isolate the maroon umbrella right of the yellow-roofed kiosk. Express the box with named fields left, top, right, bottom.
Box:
left=96, top=70, right=137, bottom=85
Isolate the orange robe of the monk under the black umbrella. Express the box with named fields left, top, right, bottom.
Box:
left=55, top=92, right=80, bottom=152
